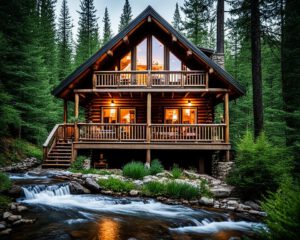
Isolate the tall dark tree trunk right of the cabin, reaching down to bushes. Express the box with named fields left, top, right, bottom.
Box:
left=251, top=0, right=264, bottom=138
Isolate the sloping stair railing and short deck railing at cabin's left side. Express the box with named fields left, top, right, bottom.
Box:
left=43, top=123, right=74, bottom=159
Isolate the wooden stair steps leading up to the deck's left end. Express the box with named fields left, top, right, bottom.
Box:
left=42, top=141, right=72, bottom=168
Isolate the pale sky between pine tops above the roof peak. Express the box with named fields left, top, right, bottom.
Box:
left=56, top=0, right=184, bottom=39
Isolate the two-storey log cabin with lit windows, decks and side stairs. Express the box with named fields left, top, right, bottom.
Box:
left=43, top=6, right=245, bottom=172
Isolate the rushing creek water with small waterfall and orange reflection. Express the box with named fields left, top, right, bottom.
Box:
left=6, top=172, right=263, bottom=240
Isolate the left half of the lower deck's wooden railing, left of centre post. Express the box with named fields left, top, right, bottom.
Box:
left=78, top=123, right=146, bottom=141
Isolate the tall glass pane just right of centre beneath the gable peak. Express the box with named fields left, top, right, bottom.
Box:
left=152, top=36, right=164, bottom=71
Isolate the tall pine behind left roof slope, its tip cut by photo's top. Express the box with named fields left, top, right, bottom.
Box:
left=75, top=0, right=100, bottom=66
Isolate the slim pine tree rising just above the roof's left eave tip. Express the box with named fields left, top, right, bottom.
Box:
left=57, top=0, right=72, bottom=80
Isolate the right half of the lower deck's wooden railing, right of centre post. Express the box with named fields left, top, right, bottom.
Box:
left=151, top=124, right=226, bottom=142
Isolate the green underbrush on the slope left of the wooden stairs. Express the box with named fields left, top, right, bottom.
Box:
left=0, top=138, right=43, bottom=166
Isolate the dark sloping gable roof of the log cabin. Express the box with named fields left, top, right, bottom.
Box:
left=52, top=5, right=245, bottom=96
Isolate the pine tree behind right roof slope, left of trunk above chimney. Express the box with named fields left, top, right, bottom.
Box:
left=181, top=0, right=213, bottom=46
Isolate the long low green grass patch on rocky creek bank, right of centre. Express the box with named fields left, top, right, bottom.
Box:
left=143, top=181, right=201, bottom=200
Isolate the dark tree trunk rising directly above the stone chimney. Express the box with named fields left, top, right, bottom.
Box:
left=217, top=0, right=224, bottom=53
